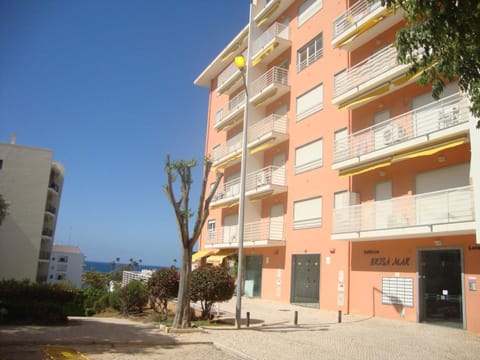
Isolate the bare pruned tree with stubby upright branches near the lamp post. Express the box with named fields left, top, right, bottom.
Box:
left=164, top=154, right=223, bottom=328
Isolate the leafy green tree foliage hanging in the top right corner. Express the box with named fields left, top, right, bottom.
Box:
left=382, top=0, right=480, bottom=128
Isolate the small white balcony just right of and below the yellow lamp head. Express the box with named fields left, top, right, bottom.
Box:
left=249, top=66, right=290, bottom=106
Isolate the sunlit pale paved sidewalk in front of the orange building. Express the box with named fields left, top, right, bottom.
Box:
left=176, top=298, right=480, bottom=360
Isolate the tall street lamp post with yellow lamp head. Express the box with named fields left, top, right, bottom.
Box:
left=235, top=55, right=248, bottom=329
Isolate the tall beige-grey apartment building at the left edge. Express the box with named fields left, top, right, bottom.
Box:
left=0, top=137, right=65, bottom=282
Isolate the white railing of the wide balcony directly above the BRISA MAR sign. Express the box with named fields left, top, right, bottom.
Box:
left=332, top=186, right=475, bottom=238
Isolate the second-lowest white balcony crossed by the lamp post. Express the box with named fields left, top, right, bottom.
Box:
left=210, top=166, right=287, bottom=208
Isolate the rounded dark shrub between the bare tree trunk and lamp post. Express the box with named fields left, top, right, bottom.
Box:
left=191, top=266, right=235, bottom=320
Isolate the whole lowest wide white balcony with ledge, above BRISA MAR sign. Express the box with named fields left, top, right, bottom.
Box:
left=331, top=186, right=475, bottom=241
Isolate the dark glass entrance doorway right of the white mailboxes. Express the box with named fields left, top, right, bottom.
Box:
left=419, top=249, right=463, bottom=327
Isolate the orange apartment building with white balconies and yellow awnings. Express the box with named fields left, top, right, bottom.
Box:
left=195, top=0, right=480, bottom=331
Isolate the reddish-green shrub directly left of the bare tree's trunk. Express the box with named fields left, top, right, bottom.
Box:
left=147, top=267, right=180, bottom=321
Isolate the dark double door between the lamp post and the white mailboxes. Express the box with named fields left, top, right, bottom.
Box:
left=291, top=254, right=320, bottom=307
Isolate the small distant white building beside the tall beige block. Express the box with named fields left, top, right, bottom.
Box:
left=47, top=245, right=85, bottom=289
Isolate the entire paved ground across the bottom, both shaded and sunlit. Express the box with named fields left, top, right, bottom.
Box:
left=0, top=299, right=480, bottom=360
